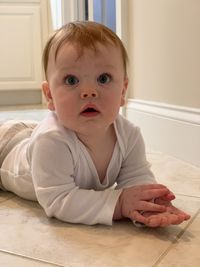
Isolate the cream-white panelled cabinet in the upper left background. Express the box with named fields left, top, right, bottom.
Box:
left=0, top=0, right=50, bottom=105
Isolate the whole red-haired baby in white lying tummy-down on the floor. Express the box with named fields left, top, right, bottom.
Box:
left=0, top=21, right=190, bottom=227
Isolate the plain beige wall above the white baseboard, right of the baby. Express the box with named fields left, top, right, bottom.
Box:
left=126, top=0, right=200, bottom=108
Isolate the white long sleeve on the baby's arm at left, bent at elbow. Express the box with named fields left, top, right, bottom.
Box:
left=30, top=134, right=121, bottom=225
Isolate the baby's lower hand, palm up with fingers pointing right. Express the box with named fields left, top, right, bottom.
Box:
left=142, top=198, right=190, bottom=227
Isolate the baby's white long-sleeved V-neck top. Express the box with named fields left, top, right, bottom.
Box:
left=1, top=113, right=155, bottom=225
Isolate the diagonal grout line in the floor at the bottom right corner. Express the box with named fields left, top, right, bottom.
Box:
left=152, top=208, right=200, bottom=267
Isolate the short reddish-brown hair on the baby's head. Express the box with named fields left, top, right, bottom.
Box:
left=43, top=21, right=128, bottom=80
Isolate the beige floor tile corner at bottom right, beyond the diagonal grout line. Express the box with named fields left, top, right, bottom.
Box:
left=155, top=212, right=200, bottom=267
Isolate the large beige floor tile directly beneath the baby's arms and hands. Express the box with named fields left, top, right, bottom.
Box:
left=0, top=197, right=199, bottom=267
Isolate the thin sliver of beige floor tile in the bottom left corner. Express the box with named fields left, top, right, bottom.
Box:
left=0, top=251, right=59, bottom=267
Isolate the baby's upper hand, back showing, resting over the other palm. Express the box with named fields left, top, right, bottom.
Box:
left=119, top=184, right=170, bottom=225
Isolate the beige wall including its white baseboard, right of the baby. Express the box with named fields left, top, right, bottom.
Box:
left=126, top=0, right=200, bottom=166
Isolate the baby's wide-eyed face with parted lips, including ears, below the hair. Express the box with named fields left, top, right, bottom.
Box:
left=43, top=43, right=128, bottom=137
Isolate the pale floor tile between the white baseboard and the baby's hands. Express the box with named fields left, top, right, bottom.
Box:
left=147, top=153, right=200, bottom=198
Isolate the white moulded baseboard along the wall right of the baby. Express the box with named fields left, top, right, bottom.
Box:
left=125, top=99, right=200, bottom=167
